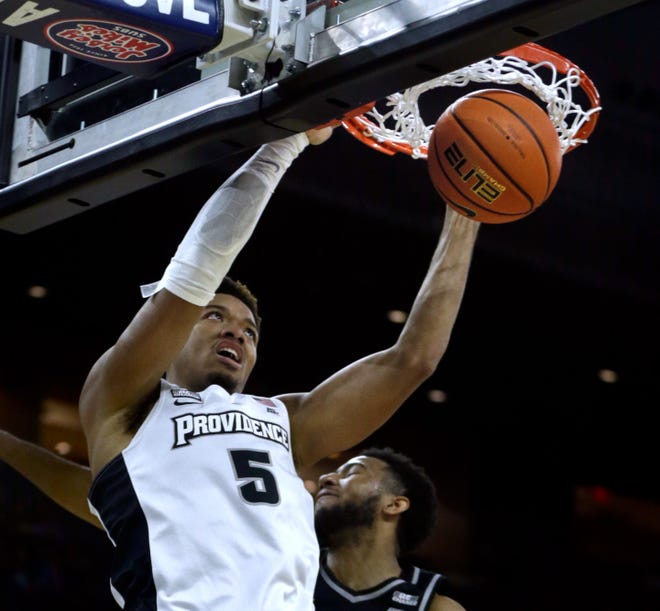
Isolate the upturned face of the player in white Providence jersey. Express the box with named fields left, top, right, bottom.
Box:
left=172, top=293, right=258, bottom=392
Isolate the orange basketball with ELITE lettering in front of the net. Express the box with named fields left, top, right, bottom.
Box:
left=427, top=89, right=562, bottom=223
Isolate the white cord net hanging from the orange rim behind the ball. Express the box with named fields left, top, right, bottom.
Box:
left=356, top=46, right=601, bottom=159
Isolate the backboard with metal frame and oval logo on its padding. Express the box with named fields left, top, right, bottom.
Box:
left=0, top=0, right=639, bottom=233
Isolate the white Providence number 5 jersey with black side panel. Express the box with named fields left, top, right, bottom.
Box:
left=89, top=380, right=319, bottom=611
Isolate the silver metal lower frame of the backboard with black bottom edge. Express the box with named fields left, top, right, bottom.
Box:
left=0, top=0, right=648, bottom=233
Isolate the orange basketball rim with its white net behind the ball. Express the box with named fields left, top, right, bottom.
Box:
left=341, top=43, right=601, bottom=159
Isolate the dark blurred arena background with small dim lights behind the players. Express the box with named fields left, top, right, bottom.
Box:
left=0, top=0, right=660, bottom=611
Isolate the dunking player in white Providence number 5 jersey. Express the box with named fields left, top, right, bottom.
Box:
left=6, top=129, right=479, bottom=611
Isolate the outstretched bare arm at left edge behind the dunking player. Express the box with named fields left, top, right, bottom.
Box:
left=0, top=430, right=101, bottom=528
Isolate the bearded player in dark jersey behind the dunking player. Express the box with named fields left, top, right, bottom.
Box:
left=314, top=448, right=465, bottom=611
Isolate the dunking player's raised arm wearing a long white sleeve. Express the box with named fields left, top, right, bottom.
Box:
left=80, top=128, right=332, bottom=474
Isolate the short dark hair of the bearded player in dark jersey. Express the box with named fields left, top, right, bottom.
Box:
left=360, top=448, right=438, bottom=555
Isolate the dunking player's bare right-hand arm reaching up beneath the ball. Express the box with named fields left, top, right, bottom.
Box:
left=280, top=208, right=479, bottom=467
